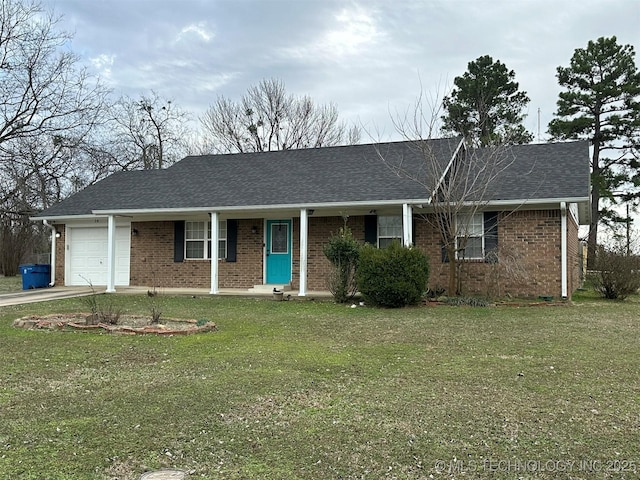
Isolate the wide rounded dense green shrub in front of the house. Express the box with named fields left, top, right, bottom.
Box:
left=356, top=242, right=429, bottom=307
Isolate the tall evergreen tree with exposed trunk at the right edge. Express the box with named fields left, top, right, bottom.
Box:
left=549, top=37, right=640, bottom=266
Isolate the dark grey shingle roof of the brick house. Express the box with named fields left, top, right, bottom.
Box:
left=38, top=139, right=589, bottom=218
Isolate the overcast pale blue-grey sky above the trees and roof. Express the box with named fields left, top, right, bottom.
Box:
left=43, top=0, right=640, bottom=140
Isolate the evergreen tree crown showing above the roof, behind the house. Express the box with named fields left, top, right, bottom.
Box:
left=442, top=55, right=533, bottom=146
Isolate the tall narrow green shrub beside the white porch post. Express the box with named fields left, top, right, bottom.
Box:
left=323, top=225, right=360, bottom=303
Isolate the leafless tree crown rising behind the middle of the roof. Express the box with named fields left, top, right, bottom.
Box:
left=200, top=79, right=360, bottom=153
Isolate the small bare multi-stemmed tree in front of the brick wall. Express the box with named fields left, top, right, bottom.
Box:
left=378, top=88, right=514, bottom=295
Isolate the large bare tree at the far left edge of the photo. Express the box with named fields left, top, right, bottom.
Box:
left=0, top=0, right=107, bottom=275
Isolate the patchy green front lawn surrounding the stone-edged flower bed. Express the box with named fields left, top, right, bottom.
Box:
left=0, top=295, right=640, bottom=480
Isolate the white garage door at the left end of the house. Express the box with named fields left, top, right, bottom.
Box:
left=65, top=226, right=131, bottom=286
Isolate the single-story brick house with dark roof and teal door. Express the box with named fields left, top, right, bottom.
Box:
left=34, top=138, right=590, bottom=298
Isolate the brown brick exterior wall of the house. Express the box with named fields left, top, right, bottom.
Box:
left=56, top=210, right=579, bottom=298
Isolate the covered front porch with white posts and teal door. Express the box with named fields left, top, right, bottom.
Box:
left=121, top=209, right=413, bottom=297
